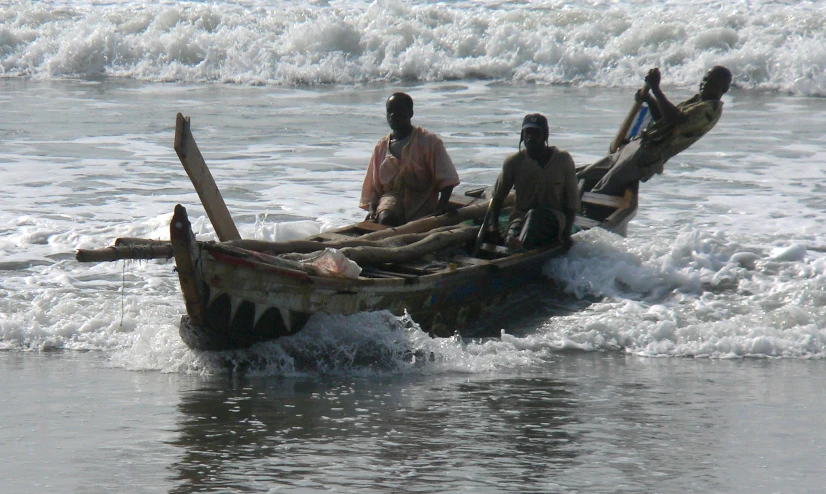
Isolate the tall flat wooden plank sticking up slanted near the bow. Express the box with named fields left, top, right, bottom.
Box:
left=175, top=113, right=241, bottom=241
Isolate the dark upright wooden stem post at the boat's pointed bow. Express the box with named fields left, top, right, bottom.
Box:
left=169, top=204, right=206, bottom=324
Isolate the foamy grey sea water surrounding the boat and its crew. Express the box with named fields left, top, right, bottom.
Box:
left=0, top=0, right=826, bottom=492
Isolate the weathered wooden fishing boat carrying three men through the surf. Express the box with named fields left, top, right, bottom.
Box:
left=78, top=114, right=637, bottom=350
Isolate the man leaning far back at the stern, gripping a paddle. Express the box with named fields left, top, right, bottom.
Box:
left=577, top=65, right=731, bottom=196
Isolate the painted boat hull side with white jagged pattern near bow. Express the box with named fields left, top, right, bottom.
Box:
left=172, top=185, right=636, bottom=350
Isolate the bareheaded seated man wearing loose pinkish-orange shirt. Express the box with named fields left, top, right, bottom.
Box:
left=359, top=93, right=459, bottom=226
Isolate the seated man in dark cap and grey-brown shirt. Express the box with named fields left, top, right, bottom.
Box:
left=488, top=113, right=579, bottom=250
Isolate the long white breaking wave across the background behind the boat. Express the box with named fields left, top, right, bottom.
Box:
left=0, top=0, right=826, bottom=95
